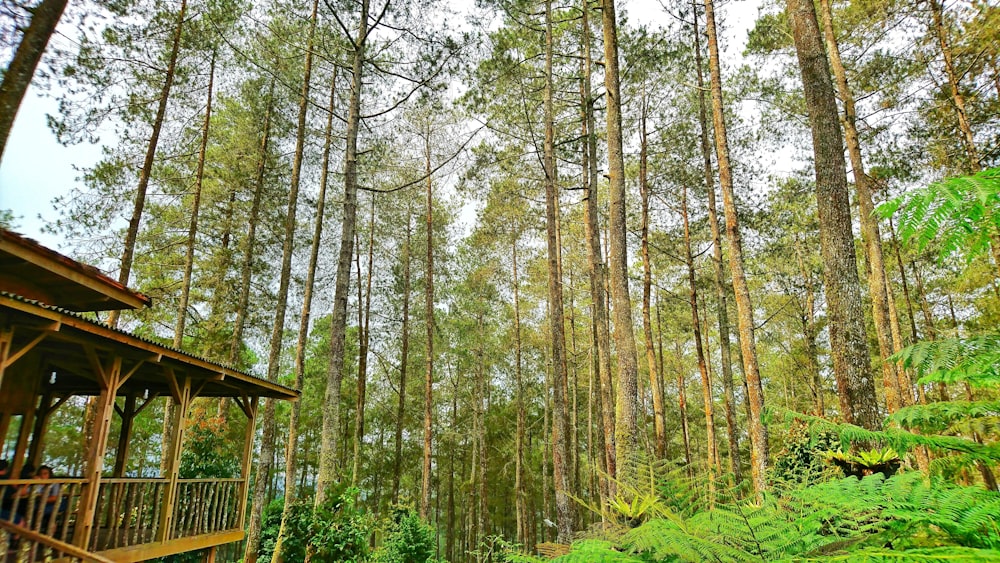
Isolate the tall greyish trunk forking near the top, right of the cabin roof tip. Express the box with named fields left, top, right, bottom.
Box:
left=316, top=0, right=369, bottom=512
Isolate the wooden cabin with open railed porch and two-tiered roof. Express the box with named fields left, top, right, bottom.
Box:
left=0, top=229, right=298, bottom=563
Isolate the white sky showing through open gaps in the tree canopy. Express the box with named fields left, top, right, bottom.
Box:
left=0, top=0, right=762, bottom=249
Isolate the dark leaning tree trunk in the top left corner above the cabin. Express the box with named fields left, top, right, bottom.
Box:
left=0, top=0, right=66, bottom=160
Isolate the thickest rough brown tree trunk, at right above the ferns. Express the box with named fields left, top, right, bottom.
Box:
left=787, top=0, right=881, bottom=429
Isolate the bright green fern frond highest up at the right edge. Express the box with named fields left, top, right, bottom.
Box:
left=878, top=168, right=1000, bottom=261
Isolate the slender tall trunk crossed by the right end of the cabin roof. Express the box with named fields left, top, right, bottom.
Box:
left=243, top=0, right=319, bottom=563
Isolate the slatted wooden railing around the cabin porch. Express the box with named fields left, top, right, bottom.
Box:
left=0, top=479, right=243, bottom=563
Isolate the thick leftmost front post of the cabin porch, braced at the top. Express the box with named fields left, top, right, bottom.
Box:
left=73, top=354, right=124, bottom=549
